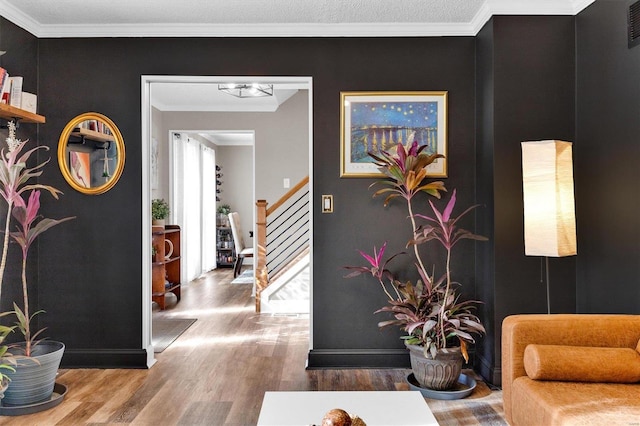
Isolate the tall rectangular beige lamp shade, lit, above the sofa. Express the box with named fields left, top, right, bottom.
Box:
left=522, top=140, right=577, bottom=257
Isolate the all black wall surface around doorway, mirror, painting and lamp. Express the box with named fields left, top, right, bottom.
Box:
left=0, top=0, right=640, bottom=383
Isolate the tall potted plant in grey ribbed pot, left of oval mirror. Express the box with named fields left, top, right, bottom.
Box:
left=0, top=123, right=73, bottom=406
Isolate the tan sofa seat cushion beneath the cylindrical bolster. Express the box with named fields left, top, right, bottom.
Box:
left=510, top=376, right=640, bottom=426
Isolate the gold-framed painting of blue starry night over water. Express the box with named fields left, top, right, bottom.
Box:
left=340, top=91, right=448, bottom=178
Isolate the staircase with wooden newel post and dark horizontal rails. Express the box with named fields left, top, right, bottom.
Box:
left=255, top=176, right=310, bottom=314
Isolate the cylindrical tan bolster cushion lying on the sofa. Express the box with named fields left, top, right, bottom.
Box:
left=524, top=345, right=640, bottom=383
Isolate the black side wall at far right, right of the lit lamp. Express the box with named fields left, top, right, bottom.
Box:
left=575, top=0, right=640, bottom=314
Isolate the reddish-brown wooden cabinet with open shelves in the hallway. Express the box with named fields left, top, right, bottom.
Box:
left=151, top=225, right=181, bottom=310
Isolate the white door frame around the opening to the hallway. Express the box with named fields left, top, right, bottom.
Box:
left=141, top=75, right=314, bottom=368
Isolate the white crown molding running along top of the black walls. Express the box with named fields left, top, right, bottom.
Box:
left=0, top=0, right=595, bottom=38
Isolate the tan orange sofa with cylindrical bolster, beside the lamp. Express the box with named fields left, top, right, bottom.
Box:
left=502, top=314, right=640, bottom=426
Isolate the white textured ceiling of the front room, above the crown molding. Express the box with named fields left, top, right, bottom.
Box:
left=2, top=0, right=483, bottom=24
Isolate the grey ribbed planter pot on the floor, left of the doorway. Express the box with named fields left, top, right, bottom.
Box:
left=2, top=340, right=64, bottom=406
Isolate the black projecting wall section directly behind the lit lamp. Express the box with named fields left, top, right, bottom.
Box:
left=476, top=16, right=577, bottom=383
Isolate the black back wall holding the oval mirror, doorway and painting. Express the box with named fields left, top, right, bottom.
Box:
left=30, top=37, right=475, bottom=365
